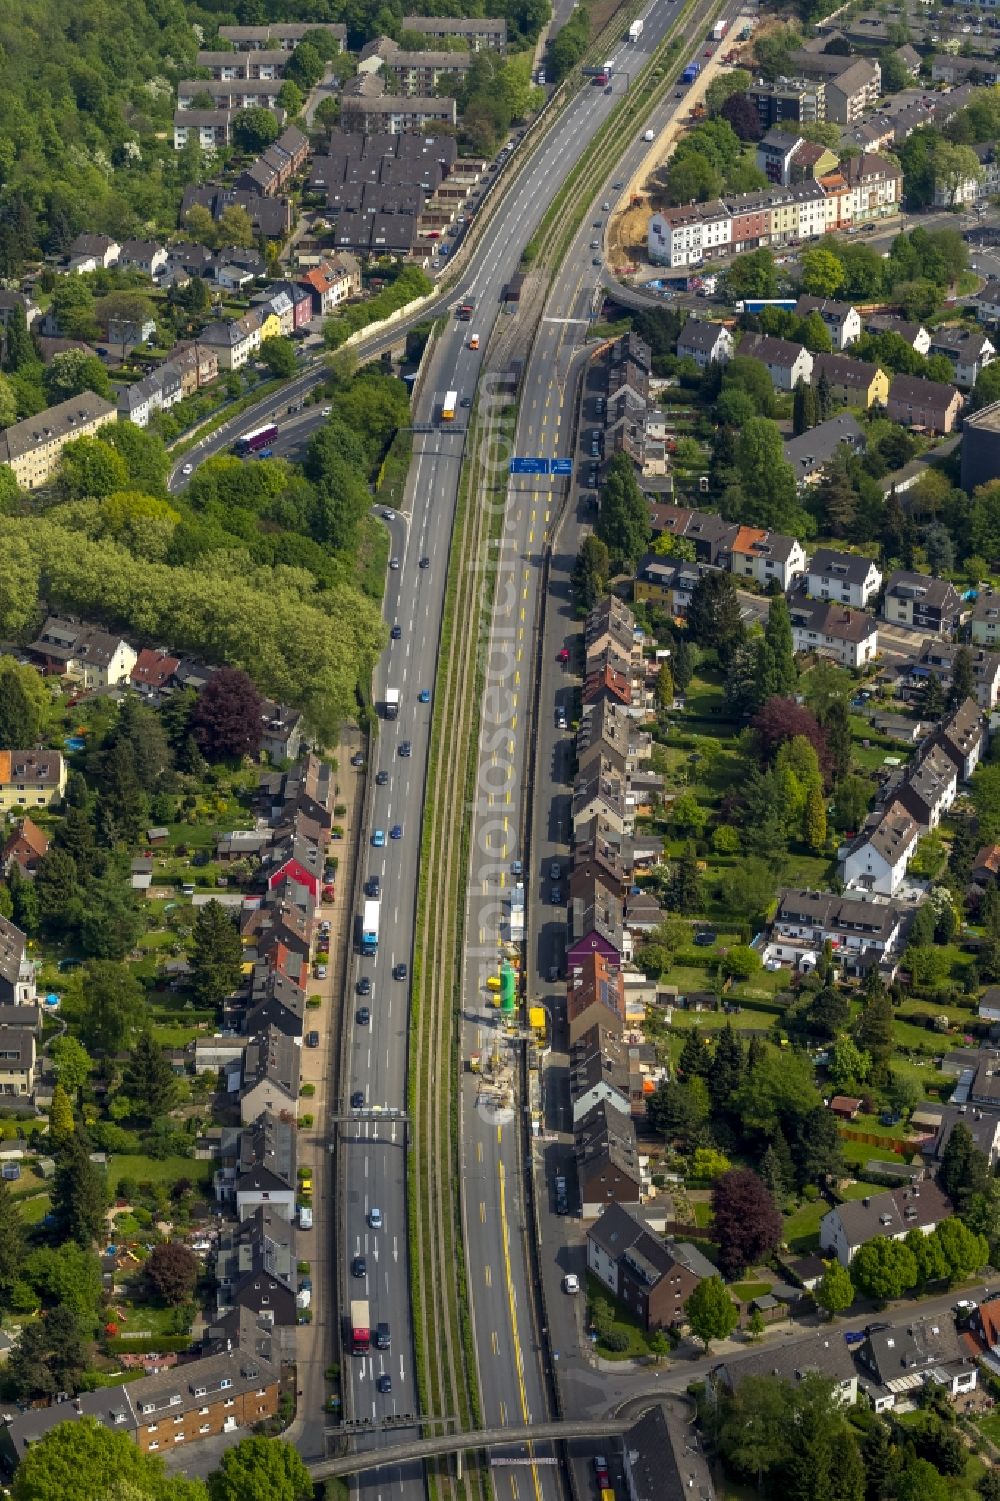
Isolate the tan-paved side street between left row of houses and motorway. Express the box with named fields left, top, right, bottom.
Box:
left=285, top=725, right=365, bottom=1459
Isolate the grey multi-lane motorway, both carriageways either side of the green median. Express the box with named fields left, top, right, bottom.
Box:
left=171, top=0, right=736, bottom=1501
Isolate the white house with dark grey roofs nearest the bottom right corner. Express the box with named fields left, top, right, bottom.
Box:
left=857, top=1320, right=977, bottom=1412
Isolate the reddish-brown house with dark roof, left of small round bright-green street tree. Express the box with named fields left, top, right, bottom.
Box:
left=587, top=1201, right=716, bottom=1333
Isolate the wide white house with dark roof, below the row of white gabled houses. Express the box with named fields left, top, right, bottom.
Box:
left=761, top=890, right=904, bottom=974
